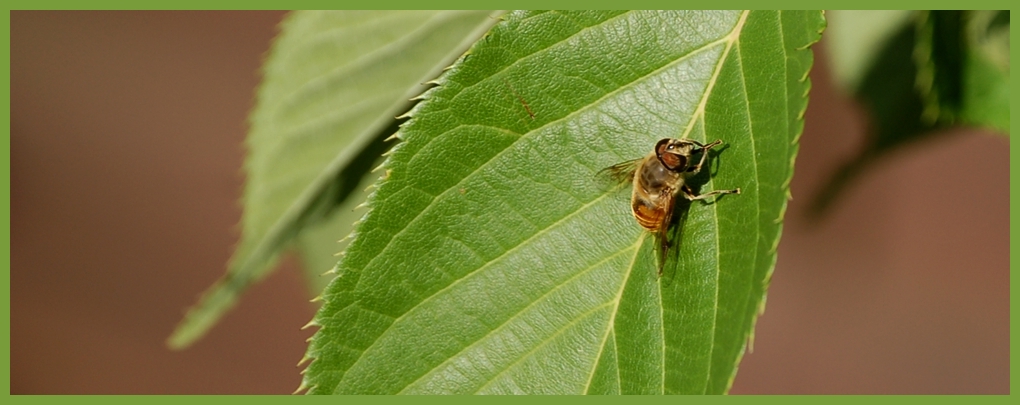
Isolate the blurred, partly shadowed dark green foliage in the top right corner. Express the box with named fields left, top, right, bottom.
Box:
left=812, top=10, right=1009, bottom=215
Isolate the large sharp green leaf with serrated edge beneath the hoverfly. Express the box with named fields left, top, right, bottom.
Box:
left=302, top=11, right=824, bottom=394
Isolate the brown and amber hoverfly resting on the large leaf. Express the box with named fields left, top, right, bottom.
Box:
left=600, top=138, right=741, bottom=276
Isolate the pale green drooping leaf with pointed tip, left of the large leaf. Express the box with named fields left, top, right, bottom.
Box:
left=167, top=11, right=496, bottom=348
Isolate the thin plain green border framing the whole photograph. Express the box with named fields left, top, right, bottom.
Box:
left=0, top=0, right=1020, bottom=397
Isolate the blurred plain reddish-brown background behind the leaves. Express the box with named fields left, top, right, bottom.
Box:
left=10, top=11, right=1010, bottom=394
